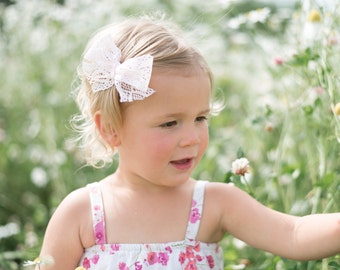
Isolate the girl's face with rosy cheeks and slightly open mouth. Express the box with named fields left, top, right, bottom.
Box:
left=118, top=71, right=211, bottom=186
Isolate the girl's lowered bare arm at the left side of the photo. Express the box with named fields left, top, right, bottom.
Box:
left=39, top=189, right=91, bottom=270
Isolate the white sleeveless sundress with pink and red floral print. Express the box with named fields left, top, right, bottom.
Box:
left=79, top=181, right=223, bottom=270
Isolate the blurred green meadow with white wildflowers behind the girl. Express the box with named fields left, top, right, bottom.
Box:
left=0, top=0, right=340, bottom=270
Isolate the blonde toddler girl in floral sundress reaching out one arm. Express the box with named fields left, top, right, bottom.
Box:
left=36, top=18, right=340, bottom=270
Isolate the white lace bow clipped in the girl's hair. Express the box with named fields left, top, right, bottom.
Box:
left=82, top=35, right=155, bottom=102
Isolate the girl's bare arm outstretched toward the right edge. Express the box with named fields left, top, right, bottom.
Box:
left=211, top=184, right=340, bottom=260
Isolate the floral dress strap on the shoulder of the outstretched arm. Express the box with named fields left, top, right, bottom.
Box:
left=185, top=181, right=207, bottom=245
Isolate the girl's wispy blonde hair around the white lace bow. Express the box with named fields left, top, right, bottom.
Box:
left=71, top=17, right=212, bottom=167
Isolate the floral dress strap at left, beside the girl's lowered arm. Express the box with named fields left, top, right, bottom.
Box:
left=86, top=182, right=106, bottom=245
